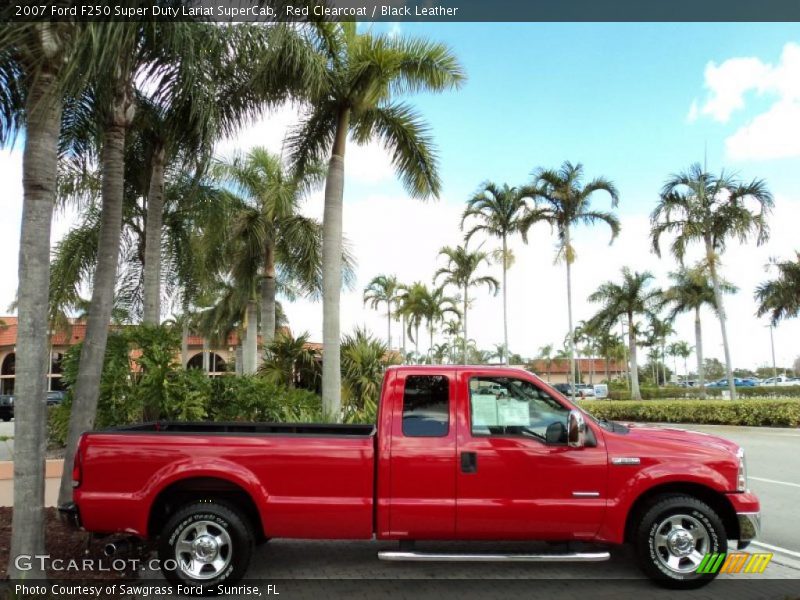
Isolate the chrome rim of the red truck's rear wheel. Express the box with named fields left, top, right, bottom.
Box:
left=175, top=521, right=228, bottom=580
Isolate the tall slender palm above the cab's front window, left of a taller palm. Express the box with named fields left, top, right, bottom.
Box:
left=461, top=181, right=525, bottom=364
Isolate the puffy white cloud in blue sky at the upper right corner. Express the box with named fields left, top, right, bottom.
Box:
left=687, top=43, right=800, bottom=160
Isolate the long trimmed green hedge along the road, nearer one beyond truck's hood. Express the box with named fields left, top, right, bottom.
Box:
left=581, top=398, right=800, bottom=427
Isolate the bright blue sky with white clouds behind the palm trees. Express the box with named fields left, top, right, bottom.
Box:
left=0, top=23, right=800, bottom=370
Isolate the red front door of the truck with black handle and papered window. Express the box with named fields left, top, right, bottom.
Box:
left=456, top=371, right=607, bottom=539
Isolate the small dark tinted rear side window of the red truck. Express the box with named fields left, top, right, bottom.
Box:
left=403, top=375, right=450, bottom=437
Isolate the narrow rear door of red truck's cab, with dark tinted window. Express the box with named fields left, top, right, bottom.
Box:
left=384, top=369, right=456, bottom=539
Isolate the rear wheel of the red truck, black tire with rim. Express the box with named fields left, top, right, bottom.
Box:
left=158, top=501, right=254, bottom=596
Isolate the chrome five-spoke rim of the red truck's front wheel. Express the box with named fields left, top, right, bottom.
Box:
left=652, top=514, right=711, bottom=573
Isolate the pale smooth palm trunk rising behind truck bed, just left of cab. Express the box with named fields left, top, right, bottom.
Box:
left=322, top=108, right=350, bottom=422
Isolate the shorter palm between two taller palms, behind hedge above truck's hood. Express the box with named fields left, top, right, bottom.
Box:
left=589, top=267, right=661, bottom=400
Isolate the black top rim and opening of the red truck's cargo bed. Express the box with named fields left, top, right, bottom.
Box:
left=105, top=421, right=375, bottom=437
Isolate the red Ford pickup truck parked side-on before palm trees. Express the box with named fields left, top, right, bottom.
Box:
left=61, top=366, right=760, bottom=591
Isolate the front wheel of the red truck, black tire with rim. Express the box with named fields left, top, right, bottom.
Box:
left=634, top=495, right=728, bottom=589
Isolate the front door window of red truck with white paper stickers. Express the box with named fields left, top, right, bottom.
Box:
left=469, top=377, right=569, bottom=444
